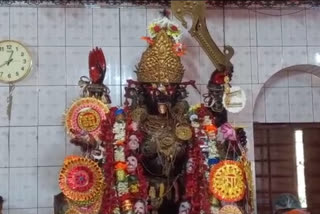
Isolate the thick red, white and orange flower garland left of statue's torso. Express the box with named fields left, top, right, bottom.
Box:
left=101, top=108, right=147, bottom=214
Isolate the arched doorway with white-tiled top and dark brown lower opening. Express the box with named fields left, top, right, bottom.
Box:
left=253, top=65, right=320, bottom=214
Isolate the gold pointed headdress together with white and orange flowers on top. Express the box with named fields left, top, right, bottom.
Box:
left=137, top=18, right=184, bottom=83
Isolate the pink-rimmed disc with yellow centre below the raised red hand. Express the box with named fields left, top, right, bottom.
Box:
left=65, top=97, right=109, bottom=137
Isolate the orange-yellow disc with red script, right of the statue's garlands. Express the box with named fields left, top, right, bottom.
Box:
left=209, top=160, right=246, bottom=202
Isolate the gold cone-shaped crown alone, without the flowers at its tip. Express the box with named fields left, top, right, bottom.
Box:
left=137, top=29, right=184, bottom=83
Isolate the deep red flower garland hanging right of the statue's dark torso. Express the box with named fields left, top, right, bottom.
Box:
left=185, top=105, right=217, bottom=214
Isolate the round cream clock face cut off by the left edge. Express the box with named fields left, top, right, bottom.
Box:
left=0, top=40, right=32, bottom=83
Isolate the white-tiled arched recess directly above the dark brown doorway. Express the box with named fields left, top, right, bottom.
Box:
left=253, top=64, right=320, bottom=123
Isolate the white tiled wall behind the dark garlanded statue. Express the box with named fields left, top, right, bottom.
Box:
left=0, top=4, right=320, bottom=214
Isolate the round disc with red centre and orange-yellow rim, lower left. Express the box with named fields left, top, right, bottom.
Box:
left=59, top=156, right=104, bottom=204
